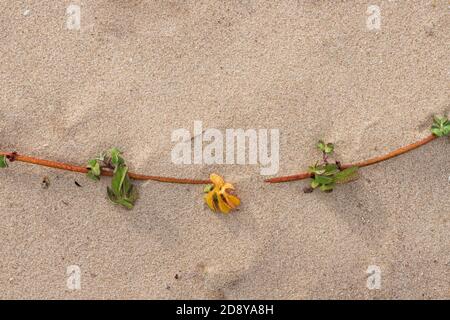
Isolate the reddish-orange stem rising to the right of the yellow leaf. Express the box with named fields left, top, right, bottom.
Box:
left=264, top=135, right=437, bottom=183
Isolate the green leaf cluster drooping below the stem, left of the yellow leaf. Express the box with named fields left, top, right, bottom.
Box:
left=87, top=148, right=138, bottom=209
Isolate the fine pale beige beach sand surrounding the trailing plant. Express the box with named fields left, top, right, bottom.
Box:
left=0, top=0, right=450, bottom=299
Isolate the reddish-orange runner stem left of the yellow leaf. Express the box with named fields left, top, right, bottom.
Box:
left=0, top=151, right=211, bottom=184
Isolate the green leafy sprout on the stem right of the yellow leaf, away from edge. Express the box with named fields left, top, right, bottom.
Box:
left=308, top=140, right=358, bottom=192
